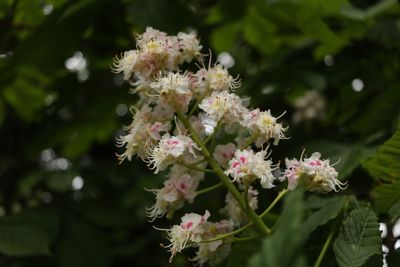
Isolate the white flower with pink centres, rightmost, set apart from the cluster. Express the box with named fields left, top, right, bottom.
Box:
left=285, top=152, right=346, bottom=192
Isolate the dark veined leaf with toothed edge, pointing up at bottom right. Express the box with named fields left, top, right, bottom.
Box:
left=333, top=208, right=381, bottom=267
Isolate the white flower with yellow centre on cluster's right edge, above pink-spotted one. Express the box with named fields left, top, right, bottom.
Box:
left=241, top=108, right=287, bottom=147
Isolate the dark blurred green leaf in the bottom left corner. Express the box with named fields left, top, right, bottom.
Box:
left=0, top=222, right=50, bottom=256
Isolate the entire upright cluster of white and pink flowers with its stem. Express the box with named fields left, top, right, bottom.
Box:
left=112, top=27, right=344, bottom=265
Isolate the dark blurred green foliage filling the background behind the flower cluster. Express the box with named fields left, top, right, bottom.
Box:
left=0, top=0, right=400, bottom=267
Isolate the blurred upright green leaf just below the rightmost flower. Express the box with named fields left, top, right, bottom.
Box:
left=248, top=191, right=304, bottom=267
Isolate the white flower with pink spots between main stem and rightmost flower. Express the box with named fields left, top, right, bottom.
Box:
left=225, top=149, right=278, bottom=188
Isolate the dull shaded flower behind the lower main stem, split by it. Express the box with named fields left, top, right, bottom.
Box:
left=221, top=186, right=258, bottom=225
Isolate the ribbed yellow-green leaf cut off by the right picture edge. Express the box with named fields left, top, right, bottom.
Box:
left=362, top=126, right=400, bottom=182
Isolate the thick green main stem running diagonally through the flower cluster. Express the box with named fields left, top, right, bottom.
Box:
left=177, top=112, right=271, bottom=235
